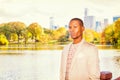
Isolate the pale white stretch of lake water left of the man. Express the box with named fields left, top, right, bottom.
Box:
left=0, top=50, right=61, bottom=80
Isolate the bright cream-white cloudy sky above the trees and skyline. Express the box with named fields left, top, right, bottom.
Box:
left=0, top=0, right=120, bottom=28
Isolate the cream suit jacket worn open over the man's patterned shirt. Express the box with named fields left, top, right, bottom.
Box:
left=60, top=40, right=100, bottom=80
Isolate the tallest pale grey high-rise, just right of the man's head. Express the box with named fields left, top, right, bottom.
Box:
left=84, top=8, right=95, bottom=29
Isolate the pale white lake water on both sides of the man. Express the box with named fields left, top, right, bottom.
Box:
left=0, top=49, right=120, bottom=80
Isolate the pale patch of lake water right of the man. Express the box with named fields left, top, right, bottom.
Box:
left=99, top=50, right=120, bottom=79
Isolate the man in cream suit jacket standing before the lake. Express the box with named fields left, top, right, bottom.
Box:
left=60, top=18, right=100, bottom=80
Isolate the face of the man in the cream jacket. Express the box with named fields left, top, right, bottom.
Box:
left=69, top=20, right=84, bottom=39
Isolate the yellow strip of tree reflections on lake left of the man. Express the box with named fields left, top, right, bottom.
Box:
left=0, top=43, right=64, bottom=50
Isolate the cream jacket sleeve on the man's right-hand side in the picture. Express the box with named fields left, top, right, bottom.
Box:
left=88, top=47, right=100, bottom=80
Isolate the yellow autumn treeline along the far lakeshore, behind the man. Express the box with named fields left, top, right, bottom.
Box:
left=0, top=19, right=120, bottom=45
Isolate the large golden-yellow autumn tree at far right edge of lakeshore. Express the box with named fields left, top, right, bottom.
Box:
left=103, top=19, right=120, bottom=45
